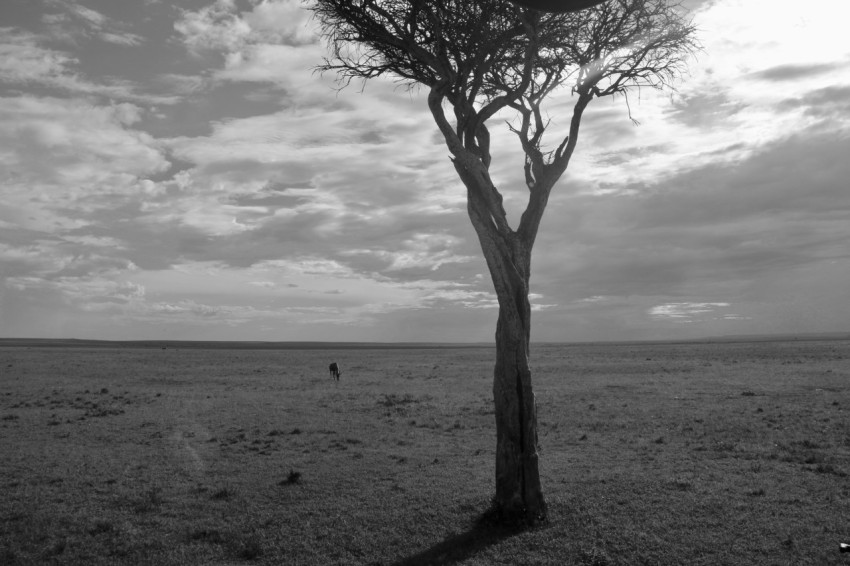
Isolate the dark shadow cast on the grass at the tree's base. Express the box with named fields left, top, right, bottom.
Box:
left=391, top=522, right=525, bottom=566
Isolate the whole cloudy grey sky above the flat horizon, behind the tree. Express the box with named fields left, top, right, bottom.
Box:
left=0, top=0, right=850, bottom=341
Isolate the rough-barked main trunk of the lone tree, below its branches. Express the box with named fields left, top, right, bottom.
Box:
left=454, top=153, right=546, bottom=524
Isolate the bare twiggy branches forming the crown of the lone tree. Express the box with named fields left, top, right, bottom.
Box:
left=312, top=0, right=699, bottom=247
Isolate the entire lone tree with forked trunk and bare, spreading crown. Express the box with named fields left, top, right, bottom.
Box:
left=311, top=0, right=698, bottom=523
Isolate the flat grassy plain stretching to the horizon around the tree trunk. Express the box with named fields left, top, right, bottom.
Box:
left=0, top=341, right=850, bottom=566
